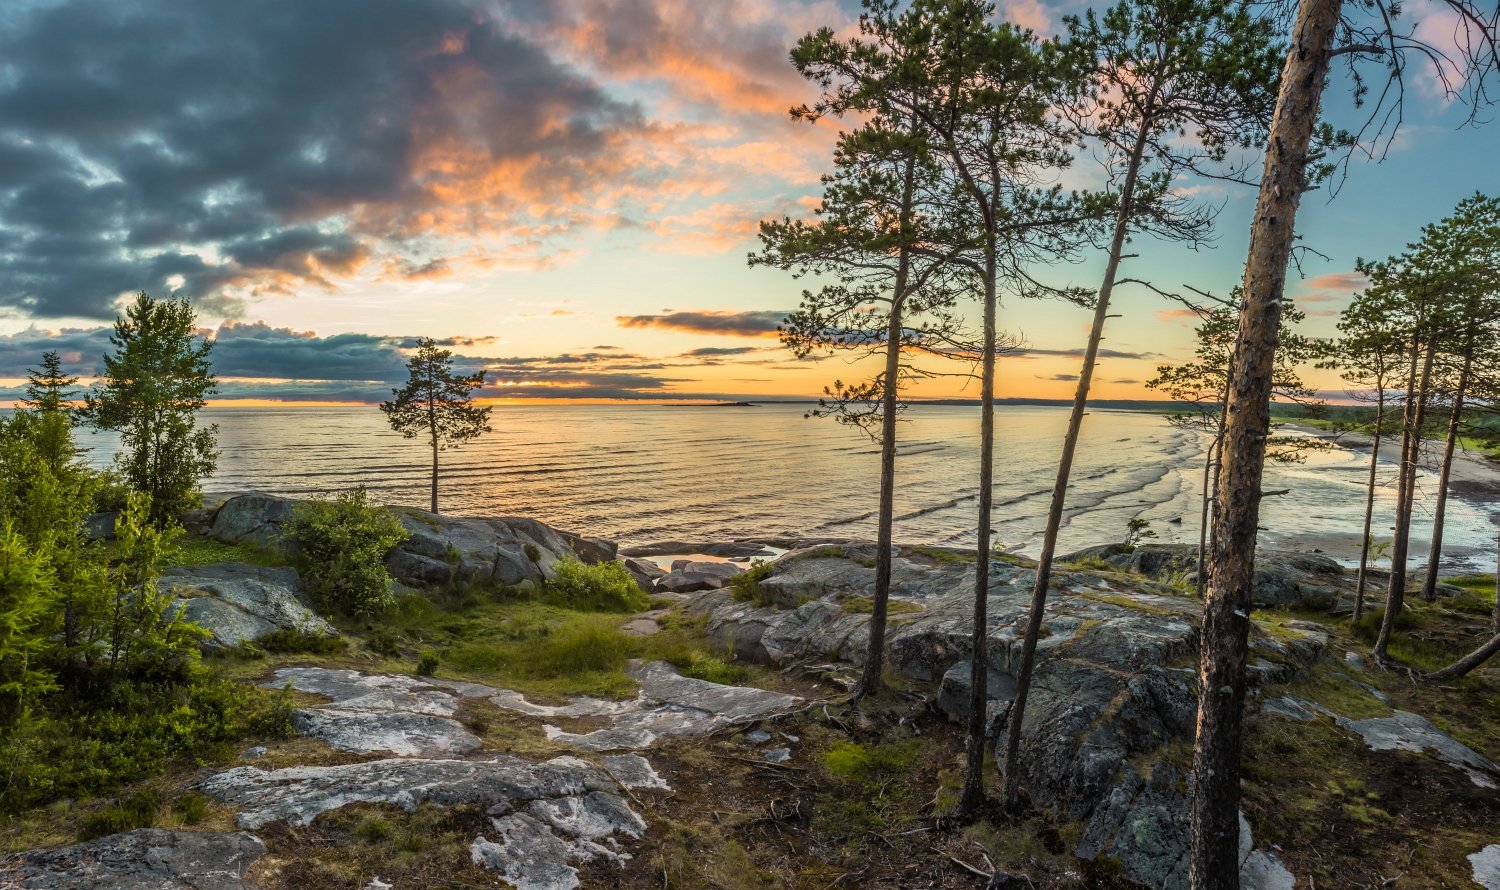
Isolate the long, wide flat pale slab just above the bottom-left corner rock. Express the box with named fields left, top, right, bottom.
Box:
left=200, top=755, right=620, bottom=830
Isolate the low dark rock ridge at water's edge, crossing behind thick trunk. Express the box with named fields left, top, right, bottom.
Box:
left=1061, top=543, right=1353, bottom=609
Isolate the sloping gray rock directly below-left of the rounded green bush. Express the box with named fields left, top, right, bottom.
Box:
left=158, top=563, right=338, bottom=647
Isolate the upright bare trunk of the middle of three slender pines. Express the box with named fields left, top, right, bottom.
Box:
left=959, top=246, right=998, bottom=815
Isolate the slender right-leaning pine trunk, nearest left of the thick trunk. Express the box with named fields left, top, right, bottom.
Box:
left=1001, top=126, right=1155, bottom=809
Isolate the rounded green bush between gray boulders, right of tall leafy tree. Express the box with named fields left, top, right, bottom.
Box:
left=291, top=486, right=407, bottom=617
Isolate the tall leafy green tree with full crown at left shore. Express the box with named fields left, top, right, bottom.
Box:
left=86, top=293, right=219, bottom=525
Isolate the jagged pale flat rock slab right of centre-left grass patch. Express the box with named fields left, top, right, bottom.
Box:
left=491, top=662, right=803, bottom=750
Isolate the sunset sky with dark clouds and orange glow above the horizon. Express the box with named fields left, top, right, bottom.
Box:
left=0, top=0, right=1500, bottom=404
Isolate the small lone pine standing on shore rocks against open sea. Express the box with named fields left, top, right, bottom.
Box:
left=380, top=338, right=489, bottom=513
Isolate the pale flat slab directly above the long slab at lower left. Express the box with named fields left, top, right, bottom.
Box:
left=266, top=668, right=498, bottom=758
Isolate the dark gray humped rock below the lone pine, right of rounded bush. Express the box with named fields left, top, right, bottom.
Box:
left=386, top=507, right=575, bottom=587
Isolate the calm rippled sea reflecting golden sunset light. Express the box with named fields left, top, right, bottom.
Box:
left=76, top=405, right=1500, bottom=570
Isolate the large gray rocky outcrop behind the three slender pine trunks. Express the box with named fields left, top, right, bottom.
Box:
left=689, top=546, right=1326, bottom=888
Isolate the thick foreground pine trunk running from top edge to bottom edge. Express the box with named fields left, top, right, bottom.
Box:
left=1188, top=0, right=1341, bottom=890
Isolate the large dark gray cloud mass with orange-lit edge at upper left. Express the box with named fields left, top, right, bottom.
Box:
left=0, top=0, right=645, bottom=318
